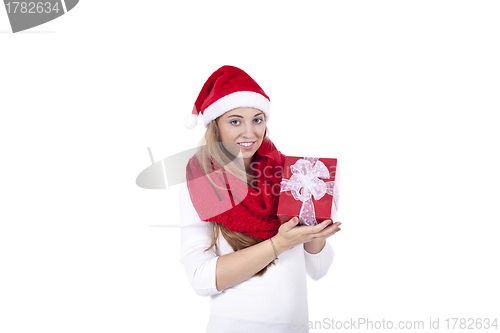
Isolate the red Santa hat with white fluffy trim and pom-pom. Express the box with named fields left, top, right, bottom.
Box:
left=184, top=66, right=271, bottom=129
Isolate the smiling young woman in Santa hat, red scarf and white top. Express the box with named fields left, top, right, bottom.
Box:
left=180, top=66, right=340, bottom=333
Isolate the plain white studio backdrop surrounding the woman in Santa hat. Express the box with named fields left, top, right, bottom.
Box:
left=0, top=0, right=500, bottom=333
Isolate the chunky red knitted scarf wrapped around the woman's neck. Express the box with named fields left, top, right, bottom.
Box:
left=186, top=138, right=285, bottom=239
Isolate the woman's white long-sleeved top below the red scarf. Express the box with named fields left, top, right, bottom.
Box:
left=179, top=183, right=333, bottom=333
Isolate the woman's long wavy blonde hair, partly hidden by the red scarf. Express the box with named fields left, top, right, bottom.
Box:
left=196, top=115, right=274, bottom=276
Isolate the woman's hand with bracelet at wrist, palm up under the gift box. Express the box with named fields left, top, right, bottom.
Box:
left=272, top=216, right=337, bottom=255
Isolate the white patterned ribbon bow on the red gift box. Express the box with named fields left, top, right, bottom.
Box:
left=280, top=157, right=339, bottom=225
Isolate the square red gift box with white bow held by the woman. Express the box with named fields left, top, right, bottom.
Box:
left=277, top=156, right=339, bottom=225
